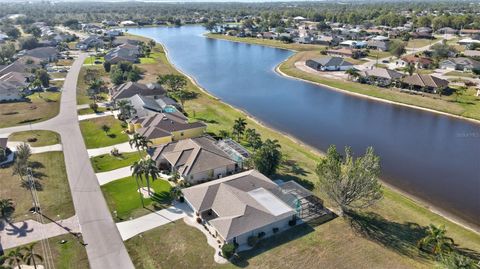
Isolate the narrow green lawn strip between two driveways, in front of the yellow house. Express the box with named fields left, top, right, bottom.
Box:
left=90, top=151, right=146, bottom=173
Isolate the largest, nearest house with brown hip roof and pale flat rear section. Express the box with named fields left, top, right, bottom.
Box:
left=182, top=170, right=297, bottom=245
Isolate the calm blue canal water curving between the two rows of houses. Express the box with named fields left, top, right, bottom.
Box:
left=129, top=26, right=480, bottom=225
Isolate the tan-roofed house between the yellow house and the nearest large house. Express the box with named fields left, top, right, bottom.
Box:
left=151, top=136, right=239, bottom=184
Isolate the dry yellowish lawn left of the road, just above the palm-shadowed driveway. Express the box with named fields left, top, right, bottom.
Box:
left=0, top=152, right=75, bottom=222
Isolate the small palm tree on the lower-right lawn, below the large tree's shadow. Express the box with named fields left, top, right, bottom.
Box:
left=418, top=224, right=454, bottom=256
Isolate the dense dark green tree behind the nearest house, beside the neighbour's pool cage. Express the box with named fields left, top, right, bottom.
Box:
left=252, top=139, right=282, bottom=176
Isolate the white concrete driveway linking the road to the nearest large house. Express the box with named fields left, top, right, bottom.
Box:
left=117, top=203, right=193, bottom=241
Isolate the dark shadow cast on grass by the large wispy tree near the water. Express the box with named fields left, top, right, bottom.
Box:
left=346, top=212, right=431, bottom=259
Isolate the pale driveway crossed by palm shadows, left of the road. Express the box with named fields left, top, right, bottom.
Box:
left=0, top=216, right=80, bottom=249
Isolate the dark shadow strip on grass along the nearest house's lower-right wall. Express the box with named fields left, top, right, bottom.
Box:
left=232, top=223, right=315, bottom=268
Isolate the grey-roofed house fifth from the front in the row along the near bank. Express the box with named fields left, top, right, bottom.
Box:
left=109, top=81, right=166, bottom=102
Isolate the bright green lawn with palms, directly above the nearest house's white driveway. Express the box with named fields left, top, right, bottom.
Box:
left=101, top=177, right=171, bottom=221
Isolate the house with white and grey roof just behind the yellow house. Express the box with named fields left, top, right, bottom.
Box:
left=128, top=94, right=182, bottom=118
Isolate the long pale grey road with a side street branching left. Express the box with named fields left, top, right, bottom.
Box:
left=0, top=54, right=134, bottom=269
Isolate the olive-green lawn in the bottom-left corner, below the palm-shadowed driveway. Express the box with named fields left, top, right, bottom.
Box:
left=5, top=234, right=89, bottom=269
